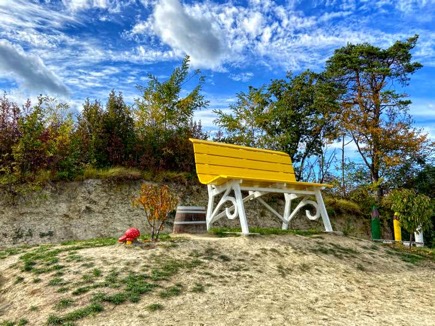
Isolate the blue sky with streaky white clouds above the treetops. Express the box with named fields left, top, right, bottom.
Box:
left=0, top=0, right=435, bottom=136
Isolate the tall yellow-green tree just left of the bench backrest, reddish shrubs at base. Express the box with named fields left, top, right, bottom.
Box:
left=134, top=57, right=208, bottom=171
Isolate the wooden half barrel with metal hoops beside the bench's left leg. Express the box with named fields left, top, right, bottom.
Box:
left=173, top=206, right=207, bottom=233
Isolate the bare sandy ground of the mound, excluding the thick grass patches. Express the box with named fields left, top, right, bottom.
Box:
left=0, top=234, right=435, bottom=326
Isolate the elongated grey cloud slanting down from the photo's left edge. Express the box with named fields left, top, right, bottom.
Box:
left=0, top=40, right=69, bottom=95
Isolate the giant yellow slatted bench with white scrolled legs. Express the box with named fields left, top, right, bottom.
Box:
left=190, top=138, right=332, bottom=234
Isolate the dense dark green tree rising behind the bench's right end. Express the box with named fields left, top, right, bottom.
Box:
left=263, top=70, right=338, bottom=179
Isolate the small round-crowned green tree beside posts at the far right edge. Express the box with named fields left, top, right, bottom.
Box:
left=388, top=189, right=433, bottom=246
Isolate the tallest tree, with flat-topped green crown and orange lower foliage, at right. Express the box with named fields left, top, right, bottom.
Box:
left=326, top=35, right=427, bottom=201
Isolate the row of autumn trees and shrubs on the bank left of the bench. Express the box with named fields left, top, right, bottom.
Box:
left=0, top=58, right=207, bottom=184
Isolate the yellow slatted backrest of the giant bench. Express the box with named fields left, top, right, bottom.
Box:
left=190, top=138, right=296, bottom=184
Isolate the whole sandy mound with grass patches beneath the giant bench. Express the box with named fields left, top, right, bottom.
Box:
left=0, top=234, right=435, bottom=326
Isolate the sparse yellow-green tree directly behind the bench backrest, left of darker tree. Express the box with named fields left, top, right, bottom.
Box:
left=213, top=87, right=269, bottom=147
